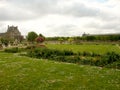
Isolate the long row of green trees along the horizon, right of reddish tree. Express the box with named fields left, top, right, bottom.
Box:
left=46, top=34, right=120, bottom=41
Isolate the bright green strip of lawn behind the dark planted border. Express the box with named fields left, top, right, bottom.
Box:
left=47, top=44, right=120, bottom=54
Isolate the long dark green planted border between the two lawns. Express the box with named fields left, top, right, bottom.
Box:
left=27, top=48, right=120, bottom=68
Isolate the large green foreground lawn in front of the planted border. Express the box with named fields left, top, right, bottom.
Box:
left=0, top=52, right=120, bottom=90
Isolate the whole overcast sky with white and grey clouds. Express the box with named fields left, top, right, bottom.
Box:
left=0, top=0, right=120, bottom=37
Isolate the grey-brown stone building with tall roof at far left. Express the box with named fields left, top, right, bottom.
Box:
left=0, top=25, right=23, bottom=41
